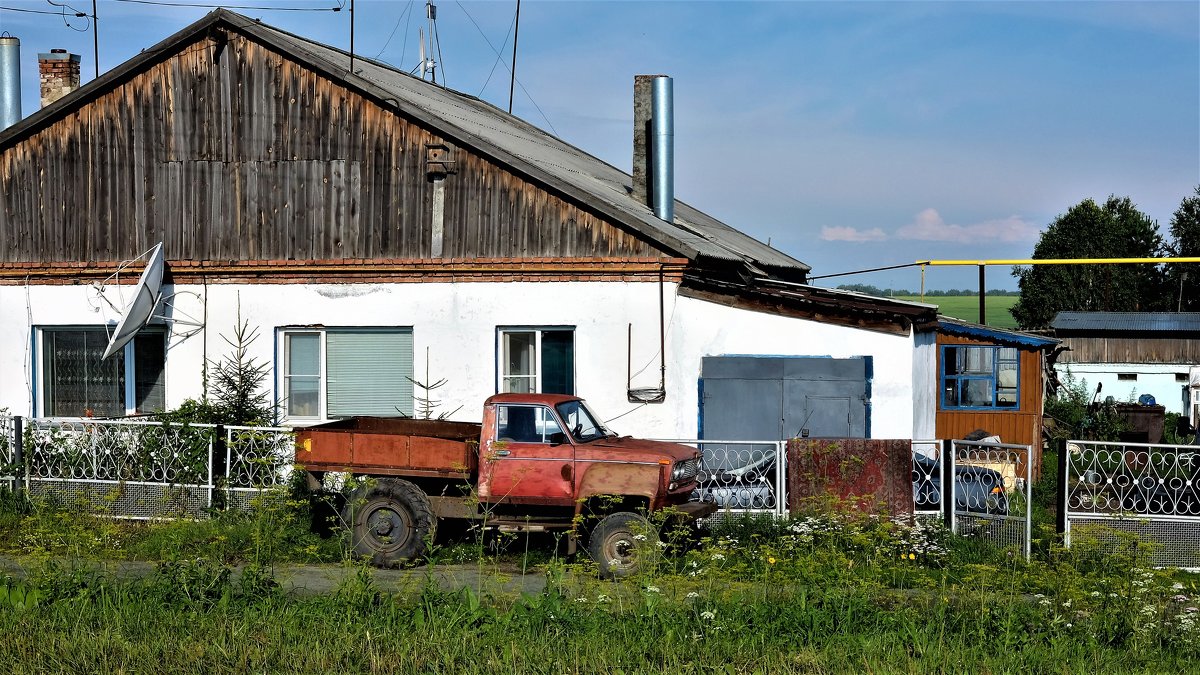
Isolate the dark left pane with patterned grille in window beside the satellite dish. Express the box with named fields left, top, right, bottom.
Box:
left=42, top=328, right=125, bottom=417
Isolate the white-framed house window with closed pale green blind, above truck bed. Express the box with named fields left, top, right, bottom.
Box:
left=280, top=328, right=413, bottom=419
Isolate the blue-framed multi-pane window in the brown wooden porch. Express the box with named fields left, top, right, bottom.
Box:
left=942, top=346, right=1020, bottom=410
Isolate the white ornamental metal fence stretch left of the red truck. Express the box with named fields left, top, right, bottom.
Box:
left=0, top=418, right=294, bottom=519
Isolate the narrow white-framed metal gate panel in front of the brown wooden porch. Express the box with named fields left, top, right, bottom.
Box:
left=947, top=441, right=1033, bottom=560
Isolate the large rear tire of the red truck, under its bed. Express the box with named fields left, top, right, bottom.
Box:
left=344, top=478, right=438, bottom=567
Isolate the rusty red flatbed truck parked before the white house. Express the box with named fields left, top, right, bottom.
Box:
left=296, top=394, right=716, bottom=578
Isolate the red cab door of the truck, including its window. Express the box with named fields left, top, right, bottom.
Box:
left=479, top=404, right=575, bottom=506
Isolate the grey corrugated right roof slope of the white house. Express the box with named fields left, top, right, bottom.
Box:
left=241, top=10, right=810, bottom=271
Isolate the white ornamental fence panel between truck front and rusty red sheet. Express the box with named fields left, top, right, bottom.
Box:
left=672, top=440, right=787, bottom=518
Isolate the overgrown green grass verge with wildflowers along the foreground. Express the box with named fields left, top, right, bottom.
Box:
left=0, top=485, right=1200, bottom=673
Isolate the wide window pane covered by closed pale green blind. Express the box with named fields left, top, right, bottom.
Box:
left=325, top=328, right=413, bottom=417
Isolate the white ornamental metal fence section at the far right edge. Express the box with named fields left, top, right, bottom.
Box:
left=1062, top=441, right=1200, bottom=569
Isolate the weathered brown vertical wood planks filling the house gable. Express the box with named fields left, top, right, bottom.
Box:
left=0, top=36, right=666, bottom=262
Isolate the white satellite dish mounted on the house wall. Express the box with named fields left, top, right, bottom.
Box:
left=95, top=241, right=204, bottom=359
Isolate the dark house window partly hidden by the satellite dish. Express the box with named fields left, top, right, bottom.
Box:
left=40, top=327, right=167, bottom=417
